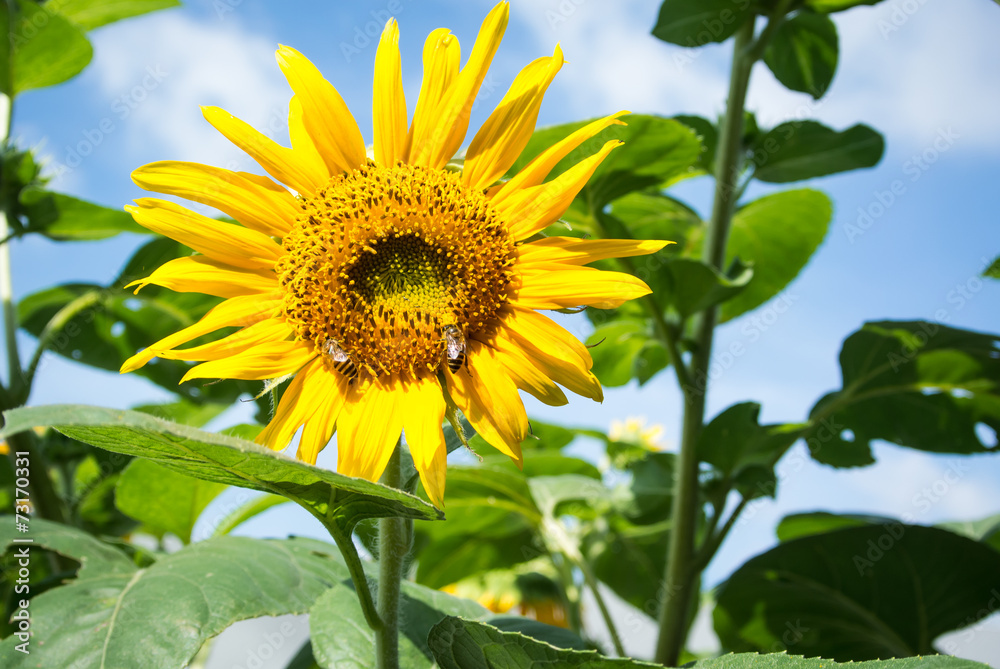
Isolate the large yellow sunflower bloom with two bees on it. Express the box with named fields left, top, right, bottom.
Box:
left=122, top=3, right=665, bottom=506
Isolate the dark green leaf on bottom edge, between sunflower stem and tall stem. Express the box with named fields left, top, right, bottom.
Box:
left=427, top=616, right=662, bottom=669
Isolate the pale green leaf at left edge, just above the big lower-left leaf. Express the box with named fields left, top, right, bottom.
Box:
left=0, top=516, right=135, bottom=576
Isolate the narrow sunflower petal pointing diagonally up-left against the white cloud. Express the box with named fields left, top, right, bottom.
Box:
left=201, top=107, right=328, bottom=195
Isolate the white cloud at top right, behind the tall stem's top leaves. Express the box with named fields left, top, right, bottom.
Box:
left=513, top=0, right=1000, bottom=150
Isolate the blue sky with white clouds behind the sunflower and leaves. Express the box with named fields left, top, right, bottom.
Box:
left=7, top=0, right=1000, bottom=661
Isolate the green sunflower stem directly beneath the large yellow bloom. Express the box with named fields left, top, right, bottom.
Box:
left=375, top=443, right=410, bottom=669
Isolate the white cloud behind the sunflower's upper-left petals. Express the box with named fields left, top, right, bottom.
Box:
left=92, top=13, right=291, bottom=170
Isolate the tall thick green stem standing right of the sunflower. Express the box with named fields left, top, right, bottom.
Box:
left=656, top=19, right=754, bottom=666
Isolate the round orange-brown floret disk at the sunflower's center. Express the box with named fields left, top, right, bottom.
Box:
left=275, top=162, right=514, bottom=375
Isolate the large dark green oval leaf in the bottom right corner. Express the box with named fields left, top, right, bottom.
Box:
left=714, top=523, right=1000, bottom=661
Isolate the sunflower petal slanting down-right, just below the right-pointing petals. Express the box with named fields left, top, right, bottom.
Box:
left=497, top=307, right=604, bottom=402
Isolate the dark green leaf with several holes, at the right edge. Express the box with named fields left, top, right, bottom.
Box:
left=806, top=321, right=1000, bottom=467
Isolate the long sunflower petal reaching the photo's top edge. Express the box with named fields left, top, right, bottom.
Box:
left=410, top=2, right=510, bottom=169
